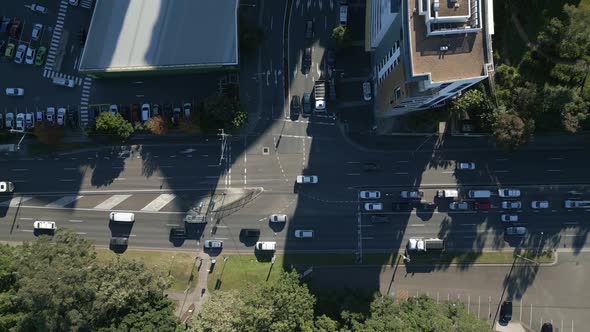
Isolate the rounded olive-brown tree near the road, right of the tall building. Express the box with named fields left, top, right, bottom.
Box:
left=493, top=106, right=530, bottom=150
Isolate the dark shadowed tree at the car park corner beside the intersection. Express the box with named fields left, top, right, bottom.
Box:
left=201, top=96, right=248, bottom=131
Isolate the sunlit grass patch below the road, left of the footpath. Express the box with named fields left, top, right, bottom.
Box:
left=96, top=248, right=199, bottom=292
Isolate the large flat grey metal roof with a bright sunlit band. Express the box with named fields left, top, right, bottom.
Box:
left=80, top=0, right=238, bottom=71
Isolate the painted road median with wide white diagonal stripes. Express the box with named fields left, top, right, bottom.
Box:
left=0, top=194, right=191, bottom=213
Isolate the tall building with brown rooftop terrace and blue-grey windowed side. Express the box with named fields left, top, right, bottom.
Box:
left=365, top=0, right=494, bottom=118
